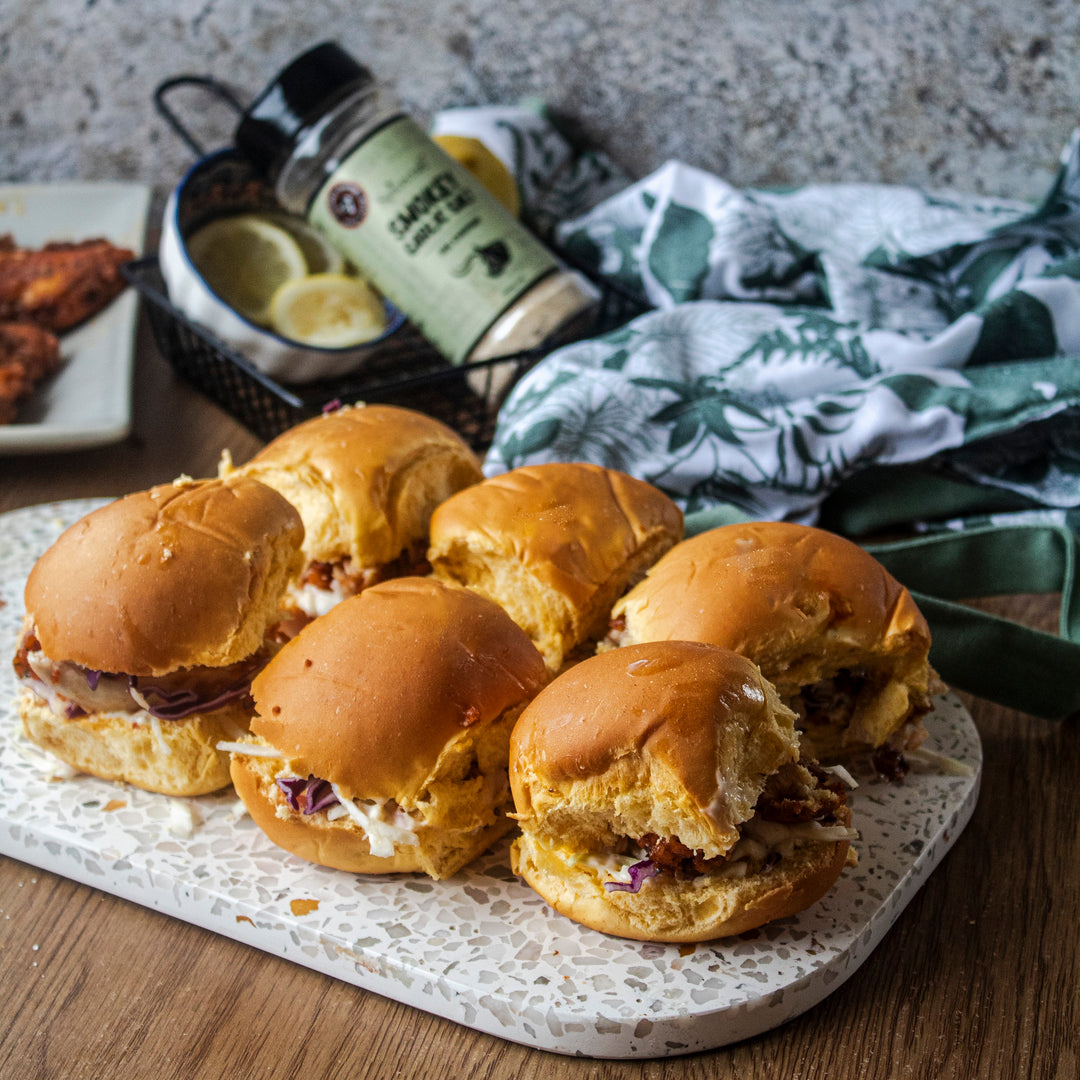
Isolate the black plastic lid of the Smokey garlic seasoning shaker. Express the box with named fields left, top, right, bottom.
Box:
left=234, top=41, right=375, bottom=180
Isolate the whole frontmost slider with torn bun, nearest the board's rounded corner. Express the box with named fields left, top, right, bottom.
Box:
left=510, top=642, right=856, bottom=942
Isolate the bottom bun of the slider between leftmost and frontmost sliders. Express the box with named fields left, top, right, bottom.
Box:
left=231, top=754, right=514, bottom=879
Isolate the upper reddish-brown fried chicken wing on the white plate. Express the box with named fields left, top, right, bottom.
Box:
left=0, top=237, right=135, bottom=334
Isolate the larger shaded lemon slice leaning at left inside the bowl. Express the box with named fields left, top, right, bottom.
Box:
left=188, top=214, right=308, bottom=325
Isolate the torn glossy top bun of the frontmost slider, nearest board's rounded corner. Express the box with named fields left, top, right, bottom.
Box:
left=510, top=642, right=799, bottom=858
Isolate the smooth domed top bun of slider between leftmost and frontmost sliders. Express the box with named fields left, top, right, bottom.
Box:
left=252, top=578, right=546, bottom=810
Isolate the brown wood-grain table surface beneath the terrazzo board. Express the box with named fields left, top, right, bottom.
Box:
left=0, top=323, right=1080, bottom=1080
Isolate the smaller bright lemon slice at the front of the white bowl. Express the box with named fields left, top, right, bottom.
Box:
left=270, top=273, right=387, bottom=349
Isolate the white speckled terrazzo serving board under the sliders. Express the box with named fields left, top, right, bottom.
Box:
left=0, top=500, right=982, bottom=1058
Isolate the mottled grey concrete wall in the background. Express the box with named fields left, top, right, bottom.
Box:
left=0, top=0, right=1080, bottom=198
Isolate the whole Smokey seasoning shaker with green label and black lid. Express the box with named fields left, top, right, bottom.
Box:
left=235, top=42, right=598, bottom=363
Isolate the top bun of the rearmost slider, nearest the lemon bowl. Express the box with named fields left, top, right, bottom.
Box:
left=230, top=405, right=483, bottom=568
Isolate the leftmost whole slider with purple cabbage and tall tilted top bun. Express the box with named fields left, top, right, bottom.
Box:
left=14, top=477, right=303, bottom=795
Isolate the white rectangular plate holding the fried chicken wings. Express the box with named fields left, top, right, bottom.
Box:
left=0, top=183, right=150, bottom=454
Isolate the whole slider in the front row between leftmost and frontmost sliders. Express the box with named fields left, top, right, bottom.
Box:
left=228, top=578, right=546, bottom=878
